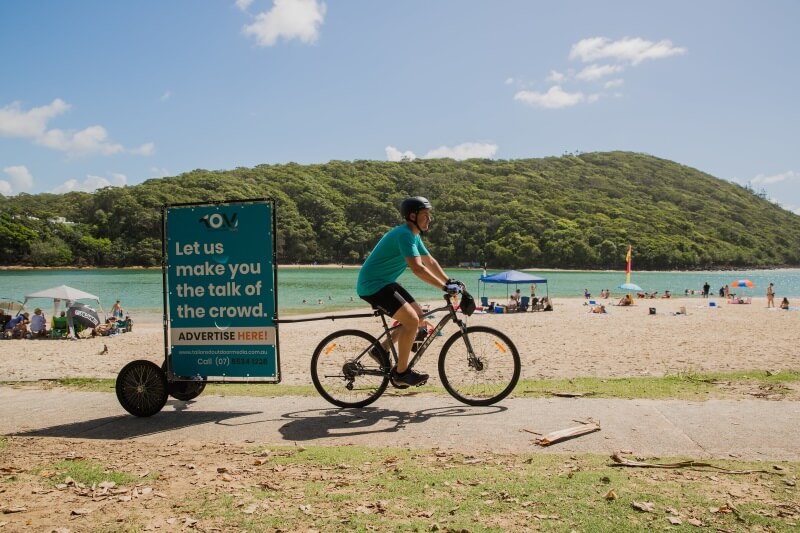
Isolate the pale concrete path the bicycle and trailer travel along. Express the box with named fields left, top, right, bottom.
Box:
left=0, top=386, right=800, bottom=461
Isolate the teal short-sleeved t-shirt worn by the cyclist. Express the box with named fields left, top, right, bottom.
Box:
left=356, top=224, right=430, bottom=296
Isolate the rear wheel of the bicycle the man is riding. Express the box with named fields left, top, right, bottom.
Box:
left=311, top=329, right=389, bottom=407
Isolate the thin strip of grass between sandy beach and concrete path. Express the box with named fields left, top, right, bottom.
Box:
left=3, top=370, right=800, bottom=401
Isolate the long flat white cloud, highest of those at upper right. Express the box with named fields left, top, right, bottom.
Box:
left=569, top=37, right=687, bottom=65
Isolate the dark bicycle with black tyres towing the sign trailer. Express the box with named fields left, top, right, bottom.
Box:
left=311, top=291, right=521, bottom=407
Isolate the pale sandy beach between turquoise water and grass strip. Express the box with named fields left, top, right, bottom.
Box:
left=0, top=298, right=800, bottom=385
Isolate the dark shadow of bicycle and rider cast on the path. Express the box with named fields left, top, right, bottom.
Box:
left=278, top=405, right=507, bottom=441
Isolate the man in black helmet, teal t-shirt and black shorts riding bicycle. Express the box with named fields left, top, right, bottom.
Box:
left=356, top=196, right=460, bottom=388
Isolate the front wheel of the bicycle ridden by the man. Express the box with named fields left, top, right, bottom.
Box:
left=439, top=326, right=521, bottom=405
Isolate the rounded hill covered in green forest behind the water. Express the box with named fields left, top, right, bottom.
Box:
left=0, top=152, right=800, bottom=270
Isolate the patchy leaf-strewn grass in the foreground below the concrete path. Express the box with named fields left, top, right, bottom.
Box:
left=178, top=447, right=800, bottom=532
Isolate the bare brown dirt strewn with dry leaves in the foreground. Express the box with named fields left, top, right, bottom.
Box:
left=0, top=437, right=800, bottom=533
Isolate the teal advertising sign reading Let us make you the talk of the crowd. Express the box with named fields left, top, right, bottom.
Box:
left=164, top=200, right=280, bottom=382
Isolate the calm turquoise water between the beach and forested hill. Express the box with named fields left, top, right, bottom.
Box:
left=0, top=268, right=800, bottom=315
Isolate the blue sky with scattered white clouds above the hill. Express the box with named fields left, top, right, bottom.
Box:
left=0, top=0, right=800, bottom=213
